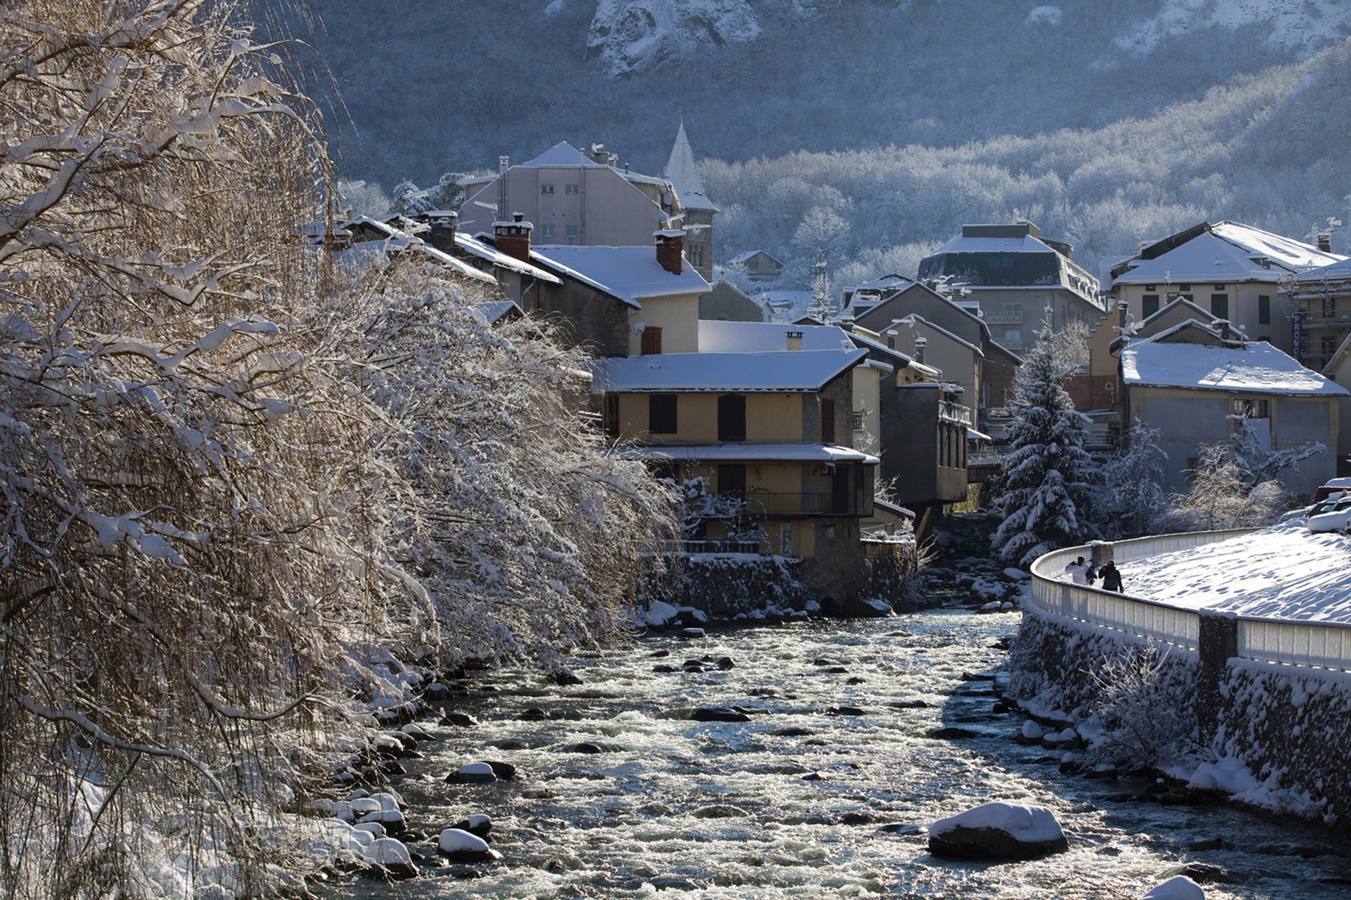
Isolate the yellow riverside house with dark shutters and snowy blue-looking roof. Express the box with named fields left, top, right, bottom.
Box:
left=593, top=341, right=878, bottom=596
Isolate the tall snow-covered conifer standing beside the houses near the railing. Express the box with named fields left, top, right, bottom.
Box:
left=992, top=314, right=1094, bottom=556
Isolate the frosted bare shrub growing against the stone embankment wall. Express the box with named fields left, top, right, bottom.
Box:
left=1089, top=645, right=1198, bottom=769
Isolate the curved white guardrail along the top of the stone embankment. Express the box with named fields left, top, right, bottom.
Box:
left=1032, top=528, right=1351, bottom=672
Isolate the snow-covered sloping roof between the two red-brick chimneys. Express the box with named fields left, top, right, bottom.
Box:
left=530, top=245, right=711, bottom=307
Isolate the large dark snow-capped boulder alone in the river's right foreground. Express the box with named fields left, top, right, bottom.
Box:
left=928, top=803, right=1070, bottom=859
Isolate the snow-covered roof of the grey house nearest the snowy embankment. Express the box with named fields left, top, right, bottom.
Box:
left=1121, top=332, right=1347, bottom=397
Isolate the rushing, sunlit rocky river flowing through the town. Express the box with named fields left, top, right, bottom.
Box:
left=331, top=609, right=1351, bottom=899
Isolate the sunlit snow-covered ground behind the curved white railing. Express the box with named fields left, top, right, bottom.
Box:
left=1117, top=524, right=1351, bottom=623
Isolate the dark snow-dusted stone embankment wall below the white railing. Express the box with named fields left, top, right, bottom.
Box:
left=1008, top=608, right=1351, bottom=826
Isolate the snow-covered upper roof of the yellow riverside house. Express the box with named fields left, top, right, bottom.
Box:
left=594, top=349, right=867, bottom=392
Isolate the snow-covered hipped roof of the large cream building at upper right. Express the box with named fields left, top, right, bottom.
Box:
left=1113, top=222, right=1343, bottom=285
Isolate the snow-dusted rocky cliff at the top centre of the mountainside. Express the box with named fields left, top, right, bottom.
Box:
left=586, top=0, right=761, bottom=77
